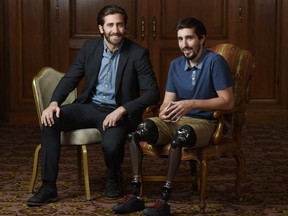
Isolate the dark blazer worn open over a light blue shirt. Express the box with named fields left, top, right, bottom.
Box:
left=51, top=37, right=160, bottom=126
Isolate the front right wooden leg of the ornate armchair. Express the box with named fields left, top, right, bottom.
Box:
left=199, top=159, right=207, bottom=214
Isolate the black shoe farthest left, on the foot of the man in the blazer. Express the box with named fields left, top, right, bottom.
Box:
left=27, top=185, right=57, bottom=206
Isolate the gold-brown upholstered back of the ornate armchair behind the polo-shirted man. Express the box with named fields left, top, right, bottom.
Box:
left=211, top=44, right=254, bottom=147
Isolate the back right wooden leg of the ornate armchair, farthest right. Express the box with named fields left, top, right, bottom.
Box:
left=235, top=150, right=245, bottom=201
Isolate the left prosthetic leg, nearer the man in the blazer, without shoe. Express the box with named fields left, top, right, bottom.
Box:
left=128, top=119, right=158, bottom=196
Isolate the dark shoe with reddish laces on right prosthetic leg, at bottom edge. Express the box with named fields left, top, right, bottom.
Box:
left=143, top=199, right=170, bottom=216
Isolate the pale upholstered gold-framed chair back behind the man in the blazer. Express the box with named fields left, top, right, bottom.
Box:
left=32, top=67, right=77, bottom=128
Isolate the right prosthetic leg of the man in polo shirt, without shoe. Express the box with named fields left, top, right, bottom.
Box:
left=162, top=125, right=197, bottom=202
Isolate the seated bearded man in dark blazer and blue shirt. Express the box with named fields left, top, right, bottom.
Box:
left=27, top=6, right=160, bottom=206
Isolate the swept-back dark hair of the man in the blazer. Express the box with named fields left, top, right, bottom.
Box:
left=97, top=5, right=128, bottom=26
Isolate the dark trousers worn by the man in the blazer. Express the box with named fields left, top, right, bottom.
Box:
left=41, top=103, right=129, bottom=181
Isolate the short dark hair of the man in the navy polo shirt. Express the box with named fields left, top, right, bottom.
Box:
left=176, top=17, right=207, bottom=39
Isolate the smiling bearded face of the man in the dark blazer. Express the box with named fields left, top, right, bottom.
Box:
left=98, top=14, right=126, bottom=52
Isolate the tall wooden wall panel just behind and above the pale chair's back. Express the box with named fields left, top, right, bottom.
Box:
left=21, top=0, right=47, bottom=98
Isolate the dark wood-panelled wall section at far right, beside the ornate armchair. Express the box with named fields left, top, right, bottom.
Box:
left=247, top=0, right=288, bottom=124
